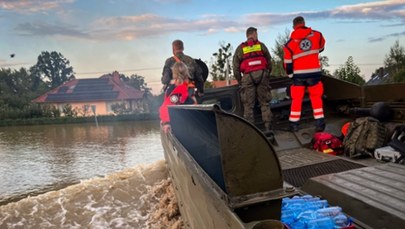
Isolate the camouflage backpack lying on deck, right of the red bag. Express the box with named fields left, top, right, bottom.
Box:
left=343, top=117, right=386, bottom=158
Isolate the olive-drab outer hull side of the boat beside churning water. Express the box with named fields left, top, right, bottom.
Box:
left=161, top=133, right=245, bottom=229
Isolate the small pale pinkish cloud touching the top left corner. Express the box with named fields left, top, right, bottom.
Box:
left=0, top=0, right=75, bottom=14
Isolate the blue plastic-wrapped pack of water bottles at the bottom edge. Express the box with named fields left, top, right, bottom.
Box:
left=281, top=195, right=354, bottom=229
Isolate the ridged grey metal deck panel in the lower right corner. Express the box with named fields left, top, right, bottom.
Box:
left=302, top=163, right=405, bottom=228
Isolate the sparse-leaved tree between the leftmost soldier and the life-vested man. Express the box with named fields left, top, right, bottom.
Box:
left=210, top=42, right=232, bottom=81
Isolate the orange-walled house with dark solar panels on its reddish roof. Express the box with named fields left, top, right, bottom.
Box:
left=32, top=72, right=149, bottom=116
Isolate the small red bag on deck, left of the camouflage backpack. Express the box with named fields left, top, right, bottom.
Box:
left=312, top=132, right=343, bottom=155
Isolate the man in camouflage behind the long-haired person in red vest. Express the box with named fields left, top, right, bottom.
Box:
left=162, top=40, right=204, bottom=96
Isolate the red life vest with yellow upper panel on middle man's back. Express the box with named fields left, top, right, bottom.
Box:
left=240, top=40, right=267, bottom=74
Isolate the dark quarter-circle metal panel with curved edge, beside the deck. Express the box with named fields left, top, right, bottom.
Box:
left=217, top=112, right=283, bottom=196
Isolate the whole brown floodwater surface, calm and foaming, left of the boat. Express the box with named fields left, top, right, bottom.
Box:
left=0, top=121, right=182, bottom=228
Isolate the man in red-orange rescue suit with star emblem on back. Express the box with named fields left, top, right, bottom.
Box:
left=284, top=16, right=325, bottom=132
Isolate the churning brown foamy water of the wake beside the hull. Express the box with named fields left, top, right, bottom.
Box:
left=0, top=160, right=184, bottom=229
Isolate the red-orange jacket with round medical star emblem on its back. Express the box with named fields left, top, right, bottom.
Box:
left=284, top=26, right=325, bottom=78
